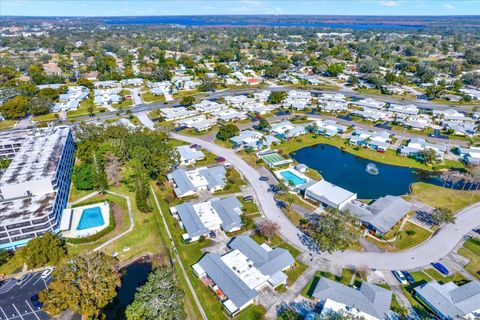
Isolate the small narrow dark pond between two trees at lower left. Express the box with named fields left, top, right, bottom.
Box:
left=104, top=260, right=152, bottom=320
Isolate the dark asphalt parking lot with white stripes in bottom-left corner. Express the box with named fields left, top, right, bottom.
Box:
left=0, top=272, right=52, bottom=320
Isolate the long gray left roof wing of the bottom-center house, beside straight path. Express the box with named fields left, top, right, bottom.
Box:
left=198, top=253, right=258, bottom=308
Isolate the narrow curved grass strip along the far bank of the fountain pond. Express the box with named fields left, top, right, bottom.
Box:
left=276, top=134, right=461, bottom=171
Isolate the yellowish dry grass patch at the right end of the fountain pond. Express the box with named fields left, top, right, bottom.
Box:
left=407, top=182, right=480, bottom=212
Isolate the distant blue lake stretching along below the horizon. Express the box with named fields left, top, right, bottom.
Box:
left=103, top=16, right=425, bottom=30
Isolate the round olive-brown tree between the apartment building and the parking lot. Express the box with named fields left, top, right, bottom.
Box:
left=21, top=232, right=67, bottom=268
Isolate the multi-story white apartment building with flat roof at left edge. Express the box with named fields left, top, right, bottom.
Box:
left=0, top=127, right=75, bottom=249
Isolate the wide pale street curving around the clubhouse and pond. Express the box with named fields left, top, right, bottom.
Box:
left=172, top=134, right=480, bottom=270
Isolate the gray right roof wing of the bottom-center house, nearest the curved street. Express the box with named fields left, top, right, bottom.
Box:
left=228, top=236, right=295, bottom=276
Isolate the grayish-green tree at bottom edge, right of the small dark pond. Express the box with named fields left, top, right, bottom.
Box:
left=125, top=267, right=187, bottom=320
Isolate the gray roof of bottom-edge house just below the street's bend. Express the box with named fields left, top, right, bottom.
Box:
left=312, top=278, right=392, bottom=319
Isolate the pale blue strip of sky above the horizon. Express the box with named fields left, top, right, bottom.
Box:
left=0, top=0, right=480, bottom=16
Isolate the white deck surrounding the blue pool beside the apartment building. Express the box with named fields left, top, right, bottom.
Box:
left=62, top=202, right=110, bottom=238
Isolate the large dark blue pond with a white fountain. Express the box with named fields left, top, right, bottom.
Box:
left=290, top=144, right=468, bottom=199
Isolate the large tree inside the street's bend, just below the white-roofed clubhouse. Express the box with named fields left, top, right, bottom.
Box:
left=300, top=210, right=361, bottom=253
